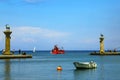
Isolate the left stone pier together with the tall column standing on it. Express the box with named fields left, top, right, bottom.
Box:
left=0, top=24, right=32, bottom=59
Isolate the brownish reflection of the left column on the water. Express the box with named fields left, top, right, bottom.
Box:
left=4, top=59, right=11, bottom=80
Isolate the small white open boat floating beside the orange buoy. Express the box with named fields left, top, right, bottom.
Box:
left=73, top=61, right=97, bottom=69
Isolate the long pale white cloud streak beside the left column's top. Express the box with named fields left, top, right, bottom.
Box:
left=13, top=26, right=68, bottom=38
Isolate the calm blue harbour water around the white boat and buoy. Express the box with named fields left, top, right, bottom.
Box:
left=0, top=51, right=120, bottom=80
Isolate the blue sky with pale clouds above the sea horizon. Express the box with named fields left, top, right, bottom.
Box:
left=0, top=0, right=120, bottom=50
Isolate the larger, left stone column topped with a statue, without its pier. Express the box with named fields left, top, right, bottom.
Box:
left=3, top=24, right=12, bottom=55
